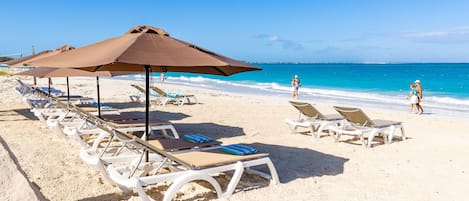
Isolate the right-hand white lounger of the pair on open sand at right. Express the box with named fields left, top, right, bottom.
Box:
left=329, top=106, right=406, bottom=148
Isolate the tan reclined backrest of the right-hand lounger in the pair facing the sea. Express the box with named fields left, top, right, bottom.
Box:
left=334, top=106, right=376, bottom=127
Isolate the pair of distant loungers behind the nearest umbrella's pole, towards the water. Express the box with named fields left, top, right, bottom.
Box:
left=129, top=84, right=199, bottom=106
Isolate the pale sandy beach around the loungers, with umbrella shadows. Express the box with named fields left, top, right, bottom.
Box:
left=0, top=76, right=469, bottom=201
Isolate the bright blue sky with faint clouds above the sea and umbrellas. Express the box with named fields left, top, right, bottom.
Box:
left=0, top=0, right=469, bottom=63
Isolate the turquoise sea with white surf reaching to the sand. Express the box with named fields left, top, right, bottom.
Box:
left=121, top=63, right=469, bottom=116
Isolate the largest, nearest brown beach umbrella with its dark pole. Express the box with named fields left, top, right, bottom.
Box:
left=29, top=26, right=261, bottom=151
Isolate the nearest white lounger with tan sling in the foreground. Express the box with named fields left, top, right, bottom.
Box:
left=107, top=132, right=279, bottom=201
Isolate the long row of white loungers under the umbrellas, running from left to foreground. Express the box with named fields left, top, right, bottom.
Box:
left=17, top=78, right=279, bottom=201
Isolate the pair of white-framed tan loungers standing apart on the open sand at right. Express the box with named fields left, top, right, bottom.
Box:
left=286, top=101, right=406, bottom=148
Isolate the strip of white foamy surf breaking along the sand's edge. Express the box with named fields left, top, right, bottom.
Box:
left=110, top=76, right=469, bottom=118
